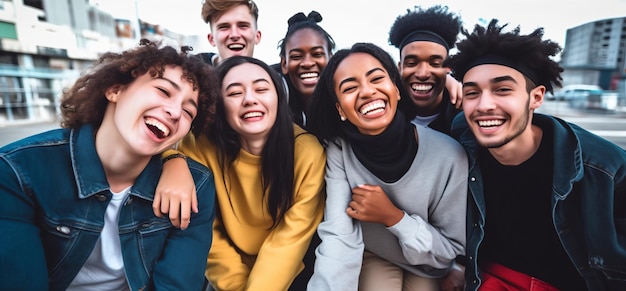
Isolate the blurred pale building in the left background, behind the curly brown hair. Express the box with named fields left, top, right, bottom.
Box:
left=0, top=0, right=198, bottom=126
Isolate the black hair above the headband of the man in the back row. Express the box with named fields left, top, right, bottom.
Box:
left=389, top=5, right=462, bottom=54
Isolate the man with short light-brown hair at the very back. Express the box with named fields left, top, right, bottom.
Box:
left=200, top=0, right=261, bottom=66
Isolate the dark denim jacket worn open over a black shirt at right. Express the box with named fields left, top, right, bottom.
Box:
left=452, top=113, right=626, bottom=290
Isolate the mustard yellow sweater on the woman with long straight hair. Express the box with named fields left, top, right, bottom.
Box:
left=179, top=126, right=326, bottom=291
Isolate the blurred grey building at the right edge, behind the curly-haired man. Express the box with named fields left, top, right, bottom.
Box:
left=561, top=17, right=626, bottom=96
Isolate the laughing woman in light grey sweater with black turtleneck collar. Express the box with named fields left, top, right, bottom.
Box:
left=307, top=43, right=467, bottom=290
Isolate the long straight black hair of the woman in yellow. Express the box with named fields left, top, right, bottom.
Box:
left=208, top=56, right=294, bottom=228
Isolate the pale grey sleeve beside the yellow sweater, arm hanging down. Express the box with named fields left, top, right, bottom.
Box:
left=308, top=143, right=364, bottom=291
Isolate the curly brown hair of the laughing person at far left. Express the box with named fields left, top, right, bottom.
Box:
left=61, top=39, right=220, bottom=135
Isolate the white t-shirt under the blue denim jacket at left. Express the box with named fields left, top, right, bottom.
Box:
left=67, top=187, right=130, bottom=291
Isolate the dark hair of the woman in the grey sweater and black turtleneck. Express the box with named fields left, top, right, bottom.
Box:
left=307, top=43, right=409, bottom=145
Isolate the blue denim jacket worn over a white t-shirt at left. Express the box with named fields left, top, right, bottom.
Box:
left=0, top=126, right=215, bottom=290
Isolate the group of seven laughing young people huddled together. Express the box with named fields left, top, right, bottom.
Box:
left=0, top=0, right=626, bottom=290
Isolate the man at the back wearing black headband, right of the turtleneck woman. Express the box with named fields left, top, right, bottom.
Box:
left=389, top=5, right=462, bottom=134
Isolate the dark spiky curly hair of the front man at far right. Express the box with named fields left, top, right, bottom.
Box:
left=445, top=19, right=563, bottom=92
